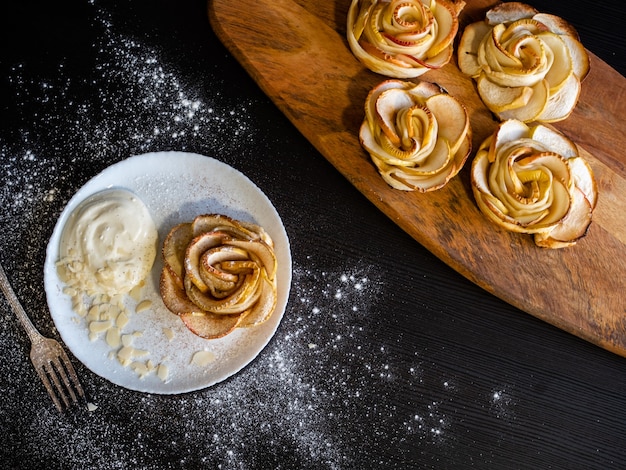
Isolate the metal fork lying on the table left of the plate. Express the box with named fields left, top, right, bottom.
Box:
left=0, top=265, right=86, bottom=412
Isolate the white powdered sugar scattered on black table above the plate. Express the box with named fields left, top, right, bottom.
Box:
left=0, top=3, right=256, bottom=231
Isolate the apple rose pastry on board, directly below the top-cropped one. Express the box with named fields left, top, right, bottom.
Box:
left=359, top=80, right=472, bottom=192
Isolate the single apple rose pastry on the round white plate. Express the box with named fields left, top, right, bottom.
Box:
left=159, top=214, right=277, bottom=338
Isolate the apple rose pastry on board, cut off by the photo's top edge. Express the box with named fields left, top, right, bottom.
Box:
left=347, top=0, right=465, bottom=78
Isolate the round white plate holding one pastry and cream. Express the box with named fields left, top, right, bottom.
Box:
left=44, top=152, right=291, bottom=394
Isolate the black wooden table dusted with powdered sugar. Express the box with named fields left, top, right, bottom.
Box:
left=0, top=0, right=626, bottom=469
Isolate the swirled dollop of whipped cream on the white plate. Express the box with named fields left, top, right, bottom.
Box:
left=59, top=189, right=158, bottom=295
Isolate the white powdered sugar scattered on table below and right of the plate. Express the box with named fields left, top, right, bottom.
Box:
left=3, top=255, right=472, bottom=469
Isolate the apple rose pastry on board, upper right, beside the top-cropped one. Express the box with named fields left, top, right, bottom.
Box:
left=458, top=2, right=589, bottom=122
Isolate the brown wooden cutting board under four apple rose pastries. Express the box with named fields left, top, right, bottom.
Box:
left=209, top=0, right=626, bottom=356
